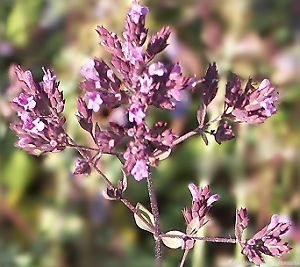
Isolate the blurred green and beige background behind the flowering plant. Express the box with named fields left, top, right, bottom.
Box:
left=0, top=0, right=300, bottom=267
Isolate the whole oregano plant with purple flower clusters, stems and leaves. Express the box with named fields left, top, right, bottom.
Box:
left=11, top=1, right=291, bottom=266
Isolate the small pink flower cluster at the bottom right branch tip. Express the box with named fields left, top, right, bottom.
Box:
left=235, top=208, right=291, bottom=265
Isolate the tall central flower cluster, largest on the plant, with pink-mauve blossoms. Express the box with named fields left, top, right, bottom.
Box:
left=77, top=2, right=196, bottom=181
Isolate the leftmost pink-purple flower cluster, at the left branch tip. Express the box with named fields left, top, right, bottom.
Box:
left=11, top=66, right=67, bottom=155
